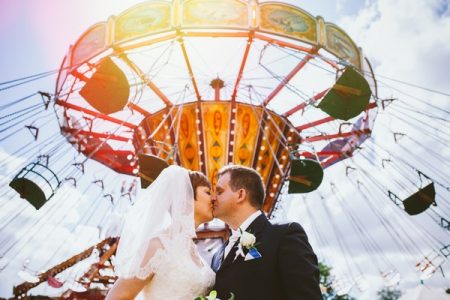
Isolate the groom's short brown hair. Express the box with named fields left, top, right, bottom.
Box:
left=218, top=165, right=266, bottom=209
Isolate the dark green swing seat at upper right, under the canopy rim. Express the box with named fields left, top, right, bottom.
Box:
left=318, top=67, right=372, bottom=120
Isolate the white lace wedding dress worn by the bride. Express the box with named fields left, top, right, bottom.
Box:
left=136, top=237, right=216, bottom=300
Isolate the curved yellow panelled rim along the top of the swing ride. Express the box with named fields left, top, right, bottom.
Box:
left=69, top=0, right=363, bottom=69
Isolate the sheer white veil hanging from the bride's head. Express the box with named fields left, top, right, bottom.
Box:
left=114, top=165, right=195, bottom=279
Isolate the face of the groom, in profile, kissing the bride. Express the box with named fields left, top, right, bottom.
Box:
left=213, top=173, right=238, bottom=220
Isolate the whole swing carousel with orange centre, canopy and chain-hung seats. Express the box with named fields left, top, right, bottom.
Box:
left=0, top=0, right=450, bottom=299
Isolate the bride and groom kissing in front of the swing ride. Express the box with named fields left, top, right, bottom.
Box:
left=106, top=165, right=322, bottom=300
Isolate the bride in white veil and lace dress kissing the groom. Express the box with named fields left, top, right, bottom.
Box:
left=106, top=166, right=215, bottom=300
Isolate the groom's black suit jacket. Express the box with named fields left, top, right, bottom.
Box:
left=212, top=214, right=322, bottom=300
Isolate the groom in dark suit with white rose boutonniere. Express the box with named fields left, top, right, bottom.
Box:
left=211, top=165, right=322, bottom=300
